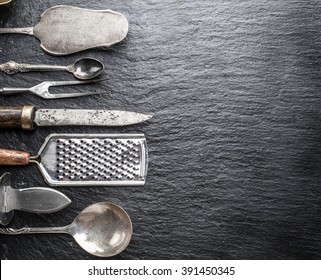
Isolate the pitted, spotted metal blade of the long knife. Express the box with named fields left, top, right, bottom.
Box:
left=34, top=109, right=152, bottom=126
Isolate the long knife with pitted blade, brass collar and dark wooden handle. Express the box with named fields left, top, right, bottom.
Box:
left=0, top=106, right=152, bottom=130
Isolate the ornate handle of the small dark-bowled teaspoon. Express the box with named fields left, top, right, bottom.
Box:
left=0, top=61, right=68, bottom=74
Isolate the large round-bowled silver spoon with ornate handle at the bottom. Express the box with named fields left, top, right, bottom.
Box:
left=0, top=202, right=133, bottom=257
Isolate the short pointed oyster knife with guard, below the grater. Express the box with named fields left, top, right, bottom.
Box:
left=0, top=173, right=71, bottom=226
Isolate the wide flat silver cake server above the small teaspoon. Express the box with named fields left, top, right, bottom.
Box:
left=0, top=5, right=128, bottom=55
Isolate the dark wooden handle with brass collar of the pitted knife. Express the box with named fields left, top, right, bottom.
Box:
left=0, top=106, right=36, bottom=130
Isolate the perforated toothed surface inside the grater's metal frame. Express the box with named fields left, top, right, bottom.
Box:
left=56, top=139, right=140, bottom=181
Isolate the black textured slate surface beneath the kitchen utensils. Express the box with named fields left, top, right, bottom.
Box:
left=0, top=0, right=321, bottom=259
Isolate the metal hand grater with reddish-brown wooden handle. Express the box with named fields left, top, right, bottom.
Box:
left=0, top=134, right=147, bottom=186
